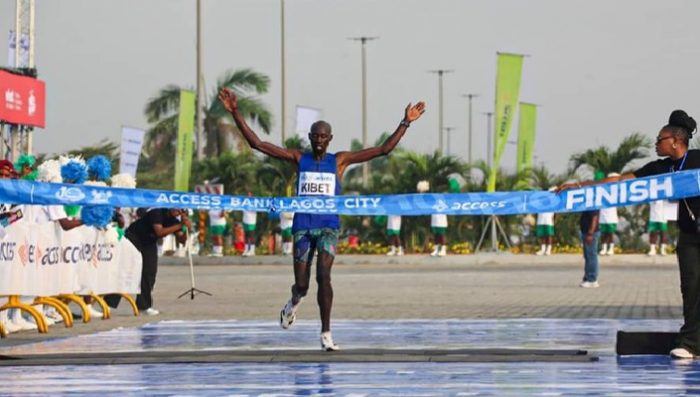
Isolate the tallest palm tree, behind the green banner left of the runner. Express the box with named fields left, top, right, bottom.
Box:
left=144, top=69, right=272, bottom=164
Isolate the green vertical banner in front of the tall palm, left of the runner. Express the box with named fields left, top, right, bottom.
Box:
left=175, top=91, right=195, bottom=192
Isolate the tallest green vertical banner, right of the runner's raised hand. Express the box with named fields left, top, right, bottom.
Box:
left=486, top=53, right=523, bottom=192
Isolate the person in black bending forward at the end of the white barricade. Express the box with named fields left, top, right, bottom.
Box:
left=105, top=208, right=192, bottom=315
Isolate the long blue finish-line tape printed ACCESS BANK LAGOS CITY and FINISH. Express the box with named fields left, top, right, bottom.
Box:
left=0, top=170, right=700, bottom=215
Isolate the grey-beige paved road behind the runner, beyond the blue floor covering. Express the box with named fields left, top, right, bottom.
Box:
left=0, top=254, right=681, bottom=344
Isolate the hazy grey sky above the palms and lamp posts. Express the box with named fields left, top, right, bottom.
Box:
left=0, top=0, right=700, bottom=172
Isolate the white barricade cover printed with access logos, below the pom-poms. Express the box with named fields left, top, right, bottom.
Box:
left=0, top=222, right=141, bottom=296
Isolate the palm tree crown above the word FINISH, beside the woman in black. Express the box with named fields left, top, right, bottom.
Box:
left=569, top=132, right=652, bottom=175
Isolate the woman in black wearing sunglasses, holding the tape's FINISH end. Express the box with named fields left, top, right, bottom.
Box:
left=560, top=110, right=700, bottom=359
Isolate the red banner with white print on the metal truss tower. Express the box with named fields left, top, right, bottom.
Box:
left=0, top=70, right=46, bottom=128
